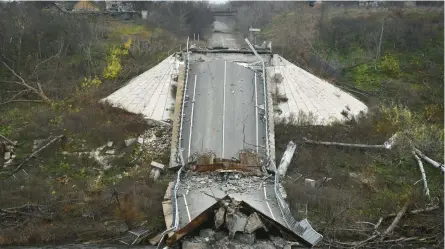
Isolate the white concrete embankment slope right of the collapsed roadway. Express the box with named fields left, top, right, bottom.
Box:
left=267, top=54, right=368, bottom=125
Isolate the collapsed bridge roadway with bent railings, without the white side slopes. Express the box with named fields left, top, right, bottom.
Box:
left=159, top=41, right=322, bottom=248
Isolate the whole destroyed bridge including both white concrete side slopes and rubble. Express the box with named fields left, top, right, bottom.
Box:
left=104, top=16, right=367, bottom=248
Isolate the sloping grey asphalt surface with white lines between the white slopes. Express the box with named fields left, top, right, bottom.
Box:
left=181, top=60, right=266, bottom=160
